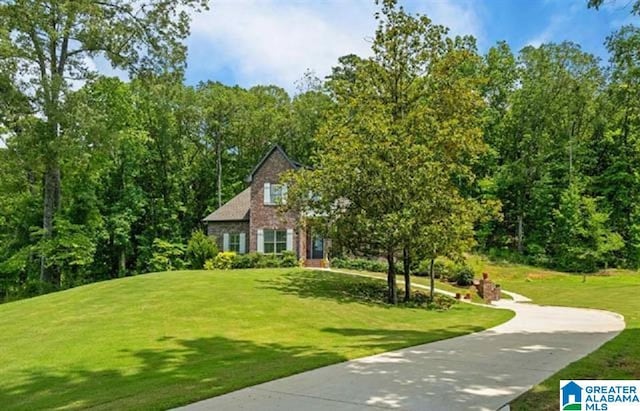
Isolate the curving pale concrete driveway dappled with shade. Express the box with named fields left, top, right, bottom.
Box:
left=175, top=294, right=624, bottom=411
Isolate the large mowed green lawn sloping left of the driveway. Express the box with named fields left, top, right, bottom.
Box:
left=0, top=269, right=512, bottom=410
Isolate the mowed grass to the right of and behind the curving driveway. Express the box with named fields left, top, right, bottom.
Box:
left=471, top=256, right=640, bottom=411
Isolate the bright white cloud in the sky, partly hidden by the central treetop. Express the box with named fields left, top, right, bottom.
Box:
left=188, top=0, right=481, bottom=90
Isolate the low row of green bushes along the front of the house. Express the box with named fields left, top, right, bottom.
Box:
left=204, top=251, right=298, bottom=270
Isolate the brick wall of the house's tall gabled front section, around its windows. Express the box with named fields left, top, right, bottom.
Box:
left=249, top=150, right=304, bottom=257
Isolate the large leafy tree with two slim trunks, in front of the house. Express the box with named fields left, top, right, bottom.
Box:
left=288, top=1, right=484, bottom=303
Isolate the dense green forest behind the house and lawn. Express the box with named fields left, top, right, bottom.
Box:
left=0, top=0, right=640, bottom=297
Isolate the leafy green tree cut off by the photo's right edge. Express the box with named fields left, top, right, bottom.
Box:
left=587, top=26, right=640, bottom=267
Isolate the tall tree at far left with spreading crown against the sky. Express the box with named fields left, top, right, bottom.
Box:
left=0, top=0, right=207, bottom=284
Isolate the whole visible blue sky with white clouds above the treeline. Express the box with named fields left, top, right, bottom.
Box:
left=179, top=0, right=640, bottom=91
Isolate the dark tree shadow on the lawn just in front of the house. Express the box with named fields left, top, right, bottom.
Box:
left=257, top=271, right=416, bottom=308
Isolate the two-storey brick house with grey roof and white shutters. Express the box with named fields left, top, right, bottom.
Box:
left=203, top=145, right=329, bottom=266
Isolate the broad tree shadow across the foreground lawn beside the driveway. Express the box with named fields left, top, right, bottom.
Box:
left=0, top=337, right=346, bottom=410
